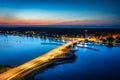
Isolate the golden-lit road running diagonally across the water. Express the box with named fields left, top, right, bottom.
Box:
left=0, top=42, right=74, bottom=80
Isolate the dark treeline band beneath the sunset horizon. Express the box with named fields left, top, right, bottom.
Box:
left=0, top=27, right=120, bottom=35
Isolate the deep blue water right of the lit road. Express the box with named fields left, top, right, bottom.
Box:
left=35, top=46, right=120, bottom=80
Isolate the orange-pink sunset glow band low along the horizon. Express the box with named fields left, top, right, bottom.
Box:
left=0, top=19, right=120, bottom=25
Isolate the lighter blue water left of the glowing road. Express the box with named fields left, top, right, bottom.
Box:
left=0, top=35, right=59, bottom=66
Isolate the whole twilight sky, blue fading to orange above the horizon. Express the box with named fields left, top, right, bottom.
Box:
left=0, top=0, right=120, bottom=25
